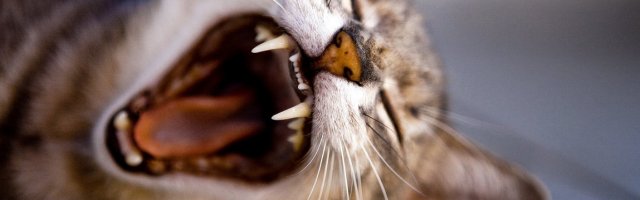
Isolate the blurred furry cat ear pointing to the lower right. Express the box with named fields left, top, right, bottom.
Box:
left=404, top=135, right=549, bottom=200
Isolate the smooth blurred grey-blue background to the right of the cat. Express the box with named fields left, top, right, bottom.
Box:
left=416, top=0, right=640, bottom=200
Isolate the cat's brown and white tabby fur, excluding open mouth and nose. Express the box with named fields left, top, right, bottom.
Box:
left=0, top=0, right=547, bottom=200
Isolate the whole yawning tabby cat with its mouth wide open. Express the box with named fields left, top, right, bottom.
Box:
left=0, top=0, right=548, bottom=200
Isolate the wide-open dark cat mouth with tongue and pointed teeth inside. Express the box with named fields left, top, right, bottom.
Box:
left=106, top=16, right=312, bottom=182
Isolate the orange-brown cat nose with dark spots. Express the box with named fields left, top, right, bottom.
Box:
left=314, top=31, right=362, bottom=83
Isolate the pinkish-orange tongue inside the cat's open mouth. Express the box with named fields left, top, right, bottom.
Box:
left=134, top=92, right=263, bottom=158
